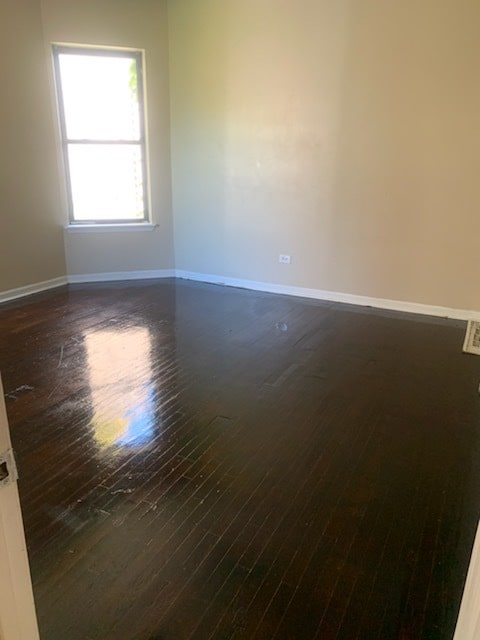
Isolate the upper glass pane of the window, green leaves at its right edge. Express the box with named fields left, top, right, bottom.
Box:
left=58, top=53, right=140, bottom=140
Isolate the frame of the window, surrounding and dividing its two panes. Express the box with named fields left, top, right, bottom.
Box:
left=52, top=44, right=151, bottom=227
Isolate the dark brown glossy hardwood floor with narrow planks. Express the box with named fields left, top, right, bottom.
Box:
left=0, top=280, right=480, bottom=640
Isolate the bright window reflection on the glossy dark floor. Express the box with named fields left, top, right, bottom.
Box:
left=84, top=327, right=155, bottom=449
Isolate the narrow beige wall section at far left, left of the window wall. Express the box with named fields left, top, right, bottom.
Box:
left=0, top=0, right=65, bottom=291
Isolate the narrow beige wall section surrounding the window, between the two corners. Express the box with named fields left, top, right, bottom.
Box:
left=41, top=0, right=174, bottom=275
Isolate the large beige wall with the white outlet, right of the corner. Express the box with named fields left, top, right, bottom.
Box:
left=169, top=0, right=480, bottom=310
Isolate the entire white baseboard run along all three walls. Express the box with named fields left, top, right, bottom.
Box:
left=0, top=269, right=480, bottom=320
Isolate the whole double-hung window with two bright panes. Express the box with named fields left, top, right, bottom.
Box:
left=53, top=46, right=148, bottom=224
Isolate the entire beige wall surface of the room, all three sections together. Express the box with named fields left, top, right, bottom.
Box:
left=0, top=0, right=480, bottom=310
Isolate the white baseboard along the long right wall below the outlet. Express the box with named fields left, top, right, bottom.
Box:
left=176, top=269, right=480, bottom=320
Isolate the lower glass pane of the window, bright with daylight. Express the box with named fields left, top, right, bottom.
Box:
left=68, top=144, right=145, bottom=222
